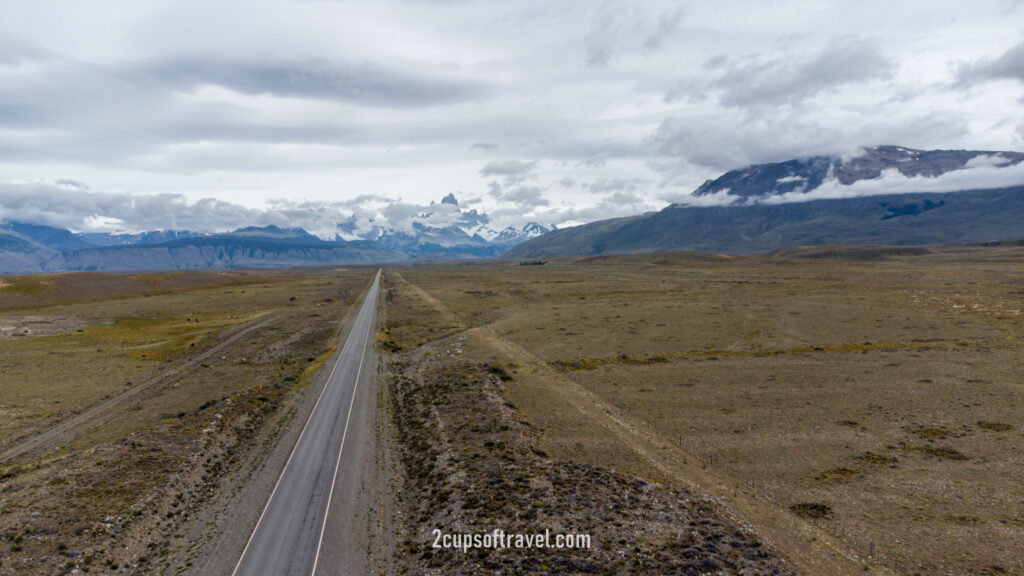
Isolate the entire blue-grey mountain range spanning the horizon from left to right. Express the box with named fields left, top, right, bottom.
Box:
left=0, top=146, right=1024, bottom=274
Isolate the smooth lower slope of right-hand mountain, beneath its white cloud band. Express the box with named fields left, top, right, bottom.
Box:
left=504, top=187, right=1024, bottom=258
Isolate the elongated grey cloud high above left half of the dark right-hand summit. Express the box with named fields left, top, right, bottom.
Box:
left=706, top=39, right=893, bottom=107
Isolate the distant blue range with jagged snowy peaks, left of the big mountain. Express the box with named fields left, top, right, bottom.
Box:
left=0, top=199, right=551, bottom=274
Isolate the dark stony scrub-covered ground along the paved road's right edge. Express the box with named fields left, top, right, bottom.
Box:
left=389, top=345, right=794, bottom=575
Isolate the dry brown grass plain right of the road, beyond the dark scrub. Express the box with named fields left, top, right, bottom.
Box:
left=389, top=246, right=1024, bottom=575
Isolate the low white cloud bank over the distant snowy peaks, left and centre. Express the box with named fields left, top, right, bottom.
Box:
left=0, top=170, right=666, bottom=240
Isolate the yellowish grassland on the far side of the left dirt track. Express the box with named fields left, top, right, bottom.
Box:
left=0, top=272, right=365, bottom=448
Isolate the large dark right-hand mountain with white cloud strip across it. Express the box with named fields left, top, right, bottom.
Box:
left=505, top=147, right=1024, bottom=258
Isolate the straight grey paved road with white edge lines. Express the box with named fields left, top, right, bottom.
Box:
left=232, top=271, right=380, bottom=576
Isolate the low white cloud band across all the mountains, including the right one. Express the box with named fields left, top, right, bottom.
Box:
left=8, top=154, right=1024, bottom=240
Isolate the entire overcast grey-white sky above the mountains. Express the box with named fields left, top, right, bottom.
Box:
left=0, top=0, right=1024, bottom=232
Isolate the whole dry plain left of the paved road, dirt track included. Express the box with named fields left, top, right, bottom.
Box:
left=0, top=269, right=374, bottom=574
